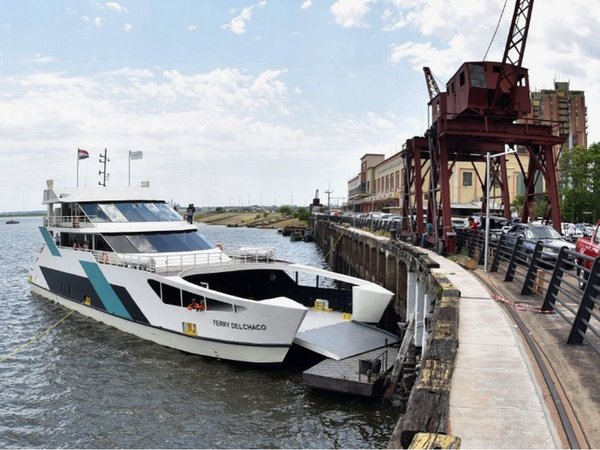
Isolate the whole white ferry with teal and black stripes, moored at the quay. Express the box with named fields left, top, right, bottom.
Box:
left=29, top=180, right=393, bottom=365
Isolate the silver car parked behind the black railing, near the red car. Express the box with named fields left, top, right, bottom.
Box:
left=505, top=223, right=575, bottom=269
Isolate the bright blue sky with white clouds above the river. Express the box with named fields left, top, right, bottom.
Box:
left=0, top=0, right=600, bottom=212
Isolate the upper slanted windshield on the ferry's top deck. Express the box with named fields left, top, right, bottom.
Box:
left=79, top=202, right=183, bottom=223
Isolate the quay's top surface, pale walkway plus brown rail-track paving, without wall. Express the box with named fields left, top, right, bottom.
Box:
left=418, top=251, right=600, bottom=448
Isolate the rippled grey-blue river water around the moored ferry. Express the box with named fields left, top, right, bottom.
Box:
left=0, top=218, right=401, bottom=448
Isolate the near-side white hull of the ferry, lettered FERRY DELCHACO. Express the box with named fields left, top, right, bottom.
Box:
left=29, top=243, right=307, bottom=365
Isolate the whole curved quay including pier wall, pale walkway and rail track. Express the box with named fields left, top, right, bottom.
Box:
left=316, top=223, right=600, bottom=448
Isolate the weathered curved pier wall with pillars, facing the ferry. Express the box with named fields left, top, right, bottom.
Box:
left=313, top=221, right=460, bottom=448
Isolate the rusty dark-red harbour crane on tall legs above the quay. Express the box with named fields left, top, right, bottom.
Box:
left=403, top=0, right=564, bottom=253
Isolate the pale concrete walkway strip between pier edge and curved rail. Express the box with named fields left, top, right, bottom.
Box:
left=428, top=252, right=563, bottom=448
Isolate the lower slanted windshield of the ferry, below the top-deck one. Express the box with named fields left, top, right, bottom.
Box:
left=103, top=231, right=214, bottom=253
